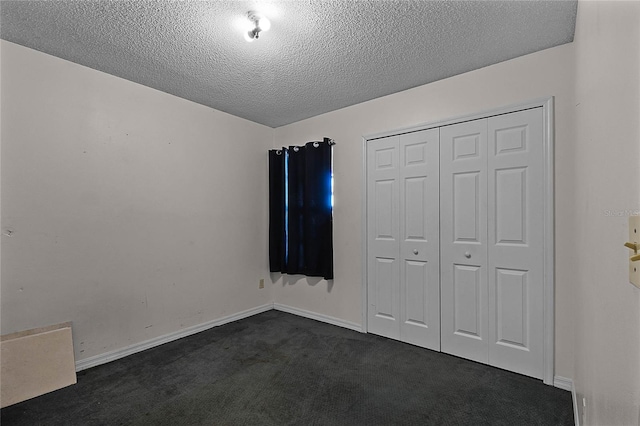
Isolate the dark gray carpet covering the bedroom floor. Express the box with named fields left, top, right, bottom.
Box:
left=1, top=311, right=573, bottom=426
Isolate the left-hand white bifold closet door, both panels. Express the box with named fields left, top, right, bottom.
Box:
left=367, top=129, right=440, bottom=350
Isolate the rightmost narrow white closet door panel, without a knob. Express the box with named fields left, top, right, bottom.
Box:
left=488, top=108, right=544, bottom=379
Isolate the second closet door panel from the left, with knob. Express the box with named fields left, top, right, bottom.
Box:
left=400, top=129, right=440, bottom=350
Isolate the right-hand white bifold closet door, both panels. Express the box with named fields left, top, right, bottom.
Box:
left=440, top=108, right=544, bottom=379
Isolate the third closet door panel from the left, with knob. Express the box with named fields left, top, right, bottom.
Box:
left=440, top=119, right=488, bottom=363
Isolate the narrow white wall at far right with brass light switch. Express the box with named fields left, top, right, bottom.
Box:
left=572, top=1, right=640, bottom=425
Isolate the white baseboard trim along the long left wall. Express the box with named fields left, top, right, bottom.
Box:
left=76, top=303, right=273, bottom=372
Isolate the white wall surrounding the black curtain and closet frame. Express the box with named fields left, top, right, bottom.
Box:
left=272, top=44, right=575, bottom=377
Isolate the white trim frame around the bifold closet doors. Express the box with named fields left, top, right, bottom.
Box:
left=361, top=96, right=555, bottom=386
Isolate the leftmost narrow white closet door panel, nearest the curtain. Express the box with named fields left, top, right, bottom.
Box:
left=367, top=136, right=400, bottom=339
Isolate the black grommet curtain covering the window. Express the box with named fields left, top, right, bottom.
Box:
left=269, top=138, right=333, bottom=280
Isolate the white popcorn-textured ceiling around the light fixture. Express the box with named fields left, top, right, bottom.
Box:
left=0, top=0, right=577, bottom=127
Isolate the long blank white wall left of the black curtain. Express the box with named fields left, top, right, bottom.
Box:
left=1, top=41, right=273, bottom=360
